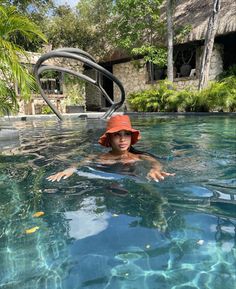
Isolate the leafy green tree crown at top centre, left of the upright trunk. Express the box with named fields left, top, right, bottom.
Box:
left=110, top=0, right=167, bottom=67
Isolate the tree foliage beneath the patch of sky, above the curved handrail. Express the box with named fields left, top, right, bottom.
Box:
left=44, top=0, right=113, bottom=57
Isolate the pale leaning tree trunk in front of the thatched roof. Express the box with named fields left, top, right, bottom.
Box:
left=198, top=0, right=221, bottom=90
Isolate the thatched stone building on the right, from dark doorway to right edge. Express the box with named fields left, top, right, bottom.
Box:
left=86, top=0, right=236, bottom=110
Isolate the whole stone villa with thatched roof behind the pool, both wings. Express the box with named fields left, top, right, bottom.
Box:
left=17, top=0, right=236, bottom=114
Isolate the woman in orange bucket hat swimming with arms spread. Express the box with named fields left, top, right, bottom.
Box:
left=47, top=115, right=175, bottom=182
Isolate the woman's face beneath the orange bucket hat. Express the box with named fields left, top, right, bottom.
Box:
left=110, top=130, right=131, bottom=152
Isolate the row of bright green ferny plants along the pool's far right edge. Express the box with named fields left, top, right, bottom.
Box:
left=128, top=76, right=236, bottom=112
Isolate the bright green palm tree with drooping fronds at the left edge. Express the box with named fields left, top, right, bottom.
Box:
left=0, top=5, right=46, bottom=114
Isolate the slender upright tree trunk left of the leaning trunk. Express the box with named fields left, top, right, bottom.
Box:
left=166, top=0, right=174, bottom=82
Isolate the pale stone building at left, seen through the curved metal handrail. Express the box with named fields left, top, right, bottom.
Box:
left=16, top=49, right=85, bottom=115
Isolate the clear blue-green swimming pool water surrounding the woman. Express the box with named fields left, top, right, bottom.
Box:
left=0, top=116, right=236, bottom=289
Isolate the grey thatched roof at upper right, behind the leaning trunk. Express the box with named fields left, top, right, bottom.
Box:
left=174, top=0, right=236, bottom=42
